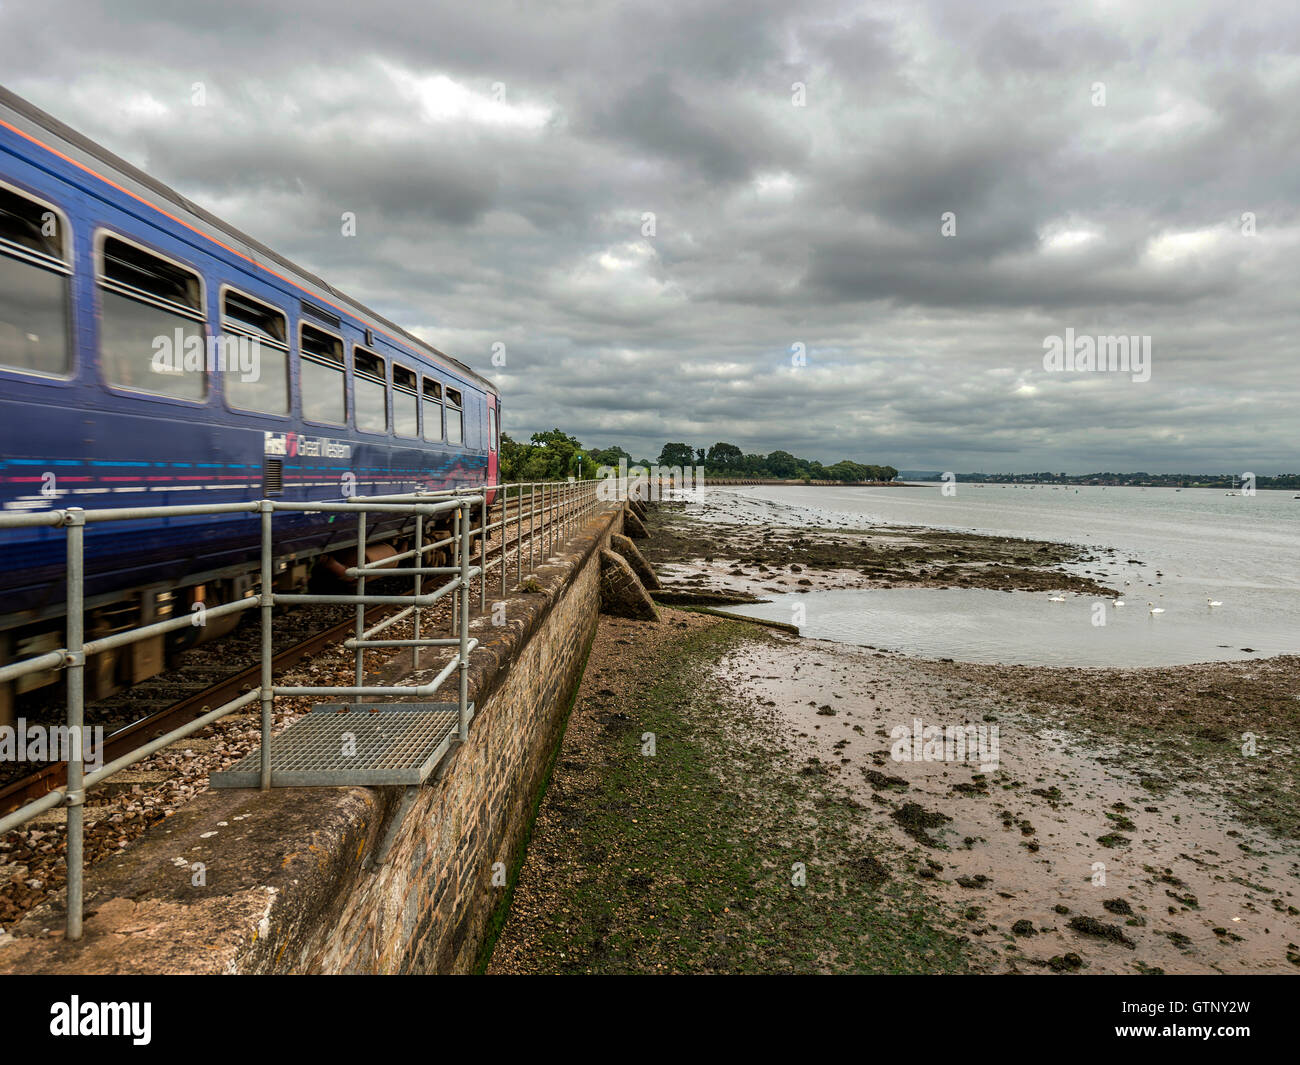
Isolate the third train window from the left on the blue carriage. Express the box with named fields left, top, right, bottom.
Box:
left=221, top=289, right=289, bottom=415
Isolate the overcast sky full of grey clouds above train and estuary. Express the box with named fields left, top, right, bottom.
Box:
left=0, top=0, right=1300, bottom=473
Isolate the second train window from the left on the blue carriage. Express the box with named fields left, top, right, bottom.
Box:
left=99, top=237, right=208, bottom=401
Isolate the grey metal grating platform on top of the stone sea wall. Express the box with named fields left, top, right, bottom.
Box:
left=209, top=702, right=473, bottom=788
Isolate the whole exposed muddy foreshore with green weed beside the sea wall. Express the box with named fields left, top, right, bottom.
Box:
left=490, top=503, right=1300, bottom=974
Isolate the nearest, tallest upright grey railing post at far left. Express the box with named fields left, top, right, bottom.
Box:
left=64, top=507, right=86, bottom=940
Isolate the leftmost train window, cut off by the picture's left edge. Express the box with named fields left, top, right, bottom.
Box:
left=0, top=187, right=72, bottom=376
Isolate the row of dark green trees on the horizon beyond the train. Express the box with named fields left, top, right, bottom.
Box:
left=501, top=429, right=898, bottom=482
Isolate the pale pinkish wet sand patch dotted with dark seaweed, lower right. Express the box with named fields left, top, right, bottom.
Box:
left=715, top=635, right=1300, bottom=973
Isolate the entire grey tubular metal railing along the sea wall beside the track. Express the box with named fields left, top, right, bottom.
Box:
left=0, top=481, right=599, bottom=940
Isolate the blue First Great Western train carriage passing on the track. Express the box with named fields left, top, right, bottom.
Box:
left=0, top=88, right=501, bottom=702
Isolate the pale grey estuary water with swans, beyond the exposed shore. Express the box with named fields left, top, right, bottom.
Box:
left=702, top=484, right=1300, bottom=667
